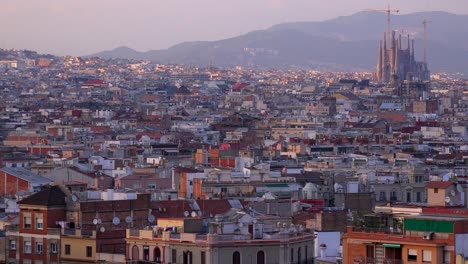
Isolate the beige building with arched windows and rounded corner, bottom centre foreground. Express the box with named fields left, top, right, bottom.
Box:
left=126, top=211, right=315, bottom=264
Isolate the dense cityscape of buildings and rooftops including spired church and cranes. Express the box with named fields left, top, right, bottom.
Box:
left=0, top=2, right=468, bottom=264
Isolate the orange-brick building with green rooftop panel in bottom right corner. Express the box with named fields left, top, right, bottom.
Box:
left=343, top=215, right=468, bottom=264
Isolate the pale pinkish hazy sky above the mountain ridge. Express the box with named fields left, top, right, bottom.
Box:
left=0, top=0, right=468, bottom=56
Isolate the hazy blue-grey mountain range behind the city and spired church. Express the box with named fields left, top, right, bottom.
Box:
left=90, top=11, right=468, bottom=75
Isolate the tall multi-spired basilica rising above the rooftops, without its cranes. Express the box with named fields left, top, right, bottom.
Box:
left=377, top=31, right=430, bottom=83
